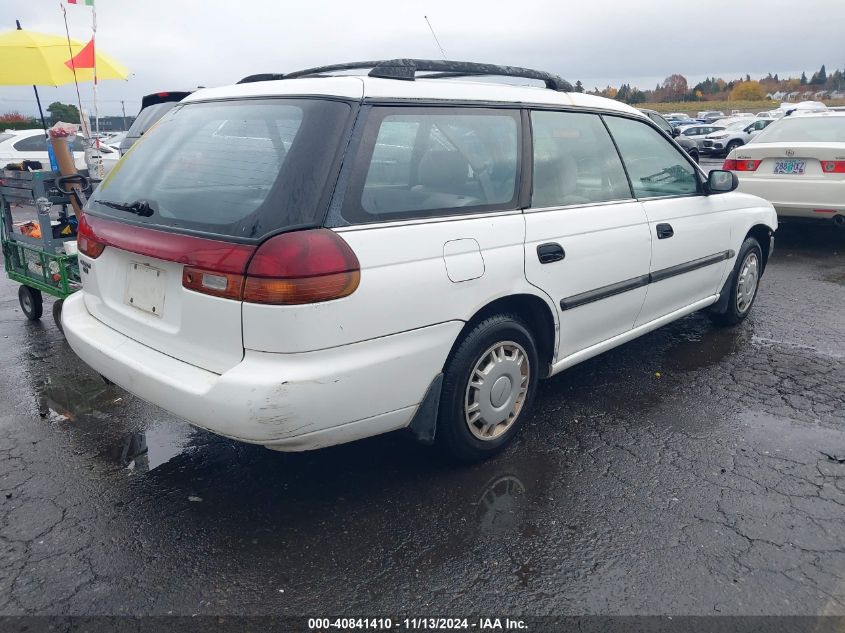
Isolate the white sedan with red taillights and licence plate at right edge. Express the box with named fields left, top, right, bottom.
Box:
left=724, top=111, right=845, bottom=228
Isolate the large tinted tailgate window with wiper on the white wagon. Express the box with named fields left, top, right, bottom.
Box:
left=88, top=99, right=351, bottom=239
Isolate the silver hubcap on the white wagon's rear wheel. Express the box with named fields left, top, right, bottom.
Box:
left=464, top=341, right=531, bottom=440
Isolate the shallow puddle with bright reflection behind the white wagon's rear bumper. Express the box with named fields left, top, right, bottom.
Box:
left=38, top=375, right=194, bottom=473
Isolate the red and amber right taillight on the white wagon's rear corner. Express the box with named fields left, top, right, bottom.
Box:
left=243, top=229, right=361, bottom=305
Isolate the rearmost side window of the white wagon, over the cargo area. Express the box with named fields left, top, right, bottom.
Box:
left=342, top=108, right=521, bottom=222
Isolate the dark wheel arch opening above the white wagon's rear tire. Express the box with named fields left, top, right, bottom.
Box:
left=446, top=294, right=558, bottom=378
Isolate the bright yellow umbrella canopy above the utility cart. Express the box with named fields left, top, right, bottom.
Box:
left=0, top=29, right=129, bottom=86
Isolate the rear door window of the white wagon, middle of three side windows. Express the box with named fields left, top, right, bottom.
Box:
left=531, top=111, right=633, bottom=207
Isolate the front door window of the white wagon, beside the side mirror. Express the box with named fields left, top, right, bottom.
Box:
left=605, top=116, right=701, bottom=198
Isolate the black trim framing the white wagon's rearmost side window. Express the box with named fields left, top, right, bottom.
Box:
left=334, top=100, right=530, bottom=223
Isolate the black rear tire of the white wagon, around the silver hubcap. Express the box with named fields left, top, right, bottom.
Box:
left=435, top=314, right=540, bottom=463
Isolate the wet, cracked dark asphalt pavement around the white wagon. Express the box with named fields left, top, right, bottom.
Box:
left=0, top=226, right=845, bottom=615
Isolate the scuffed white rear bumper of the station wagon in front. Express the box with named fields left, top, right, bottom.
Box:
left=62, top=292, right=463, bottom=451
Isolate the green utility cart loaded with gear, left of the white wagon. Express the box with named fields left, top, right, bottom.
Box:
left=0, top=169, right=90, bottom=330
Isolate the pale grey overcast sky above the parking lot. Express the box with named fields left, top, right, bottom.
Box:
left=0, top=0, right=845, bottom=114
